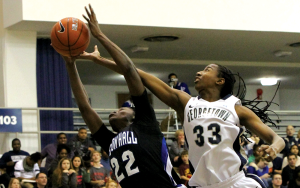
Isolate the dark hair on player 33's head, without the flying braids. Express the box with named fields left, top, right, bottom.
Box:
left=216, top=64, right=236, bottom=98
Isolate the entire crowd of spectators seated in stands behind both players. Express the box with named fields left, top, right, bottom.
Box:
left=0, top=123, right=300, bottom=188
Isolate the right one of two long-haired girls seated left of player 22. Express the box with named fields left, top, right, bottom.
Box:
left=72, top=156, right=91, bottom=188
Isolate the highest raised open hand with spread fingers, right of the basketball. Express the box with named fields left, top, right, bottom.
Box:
left=82, top=4, right=102, bottom=37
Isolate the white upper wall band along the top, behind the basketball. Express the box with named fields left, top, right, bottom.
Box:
left=4, top=0, right=300, bottom=32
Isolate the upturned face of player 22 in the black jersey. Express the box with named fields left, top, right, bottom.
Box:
left=109, top=107, right=134, bottom=132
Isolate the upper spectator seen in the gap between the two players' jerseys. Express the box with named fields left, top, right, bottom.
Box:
left=170, top=129, right=188, bottom=167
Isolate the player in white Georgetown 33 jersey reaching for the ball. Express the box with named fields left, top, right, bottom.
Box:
left=81, top=3, right=284, bottom=188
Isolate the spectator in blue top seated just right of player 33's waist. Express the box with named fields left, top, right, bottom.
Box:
left=247, top=157, right=270, bottom=187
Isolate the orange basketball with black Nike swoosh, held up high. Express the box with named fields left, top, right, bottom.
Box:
left=51, top=17, right=90, bottom=57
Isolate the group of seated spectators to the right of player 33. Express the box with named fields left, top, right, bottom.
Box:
left=241, top=125, right=300, bottom=188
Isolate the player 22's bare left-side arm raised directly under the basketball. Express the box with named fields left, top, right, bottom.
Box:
left=63, top=57, right=103, bottom=134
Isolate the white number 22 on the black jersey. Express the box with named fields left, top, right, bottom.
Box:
left=110, top=150, right=140, bottom=182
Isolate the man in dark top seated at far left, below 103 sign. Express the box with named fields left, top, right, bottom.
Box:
left=0, top=138, right=29, bottom=177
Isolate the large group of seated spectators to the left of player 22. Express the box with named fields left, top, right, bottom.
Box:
left=0, top=128, right=120, bottom=188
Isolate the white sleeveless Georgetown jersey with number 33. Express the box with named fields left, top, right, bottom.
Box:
left=183, top=95, right=247, bottom=186
